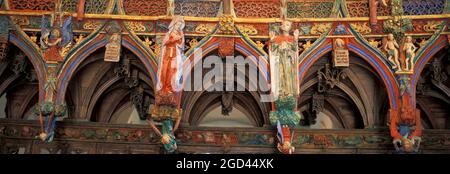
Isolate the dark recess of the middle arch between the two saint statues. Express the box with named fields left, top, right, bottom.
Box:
left=181, top=50, right=270, bottom=127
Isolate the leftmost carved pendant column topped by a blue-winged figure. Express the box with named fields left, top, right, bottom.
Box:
left=36, top=0, right=73, bottom=142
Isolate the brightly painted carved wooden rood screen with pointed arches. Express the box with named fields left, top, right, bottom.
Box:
left=0, top=0, right=450, bottom=154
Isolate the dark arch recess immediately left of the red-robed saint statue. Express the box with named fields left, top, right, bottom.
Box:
left=65, top=48, right=154, bottom=123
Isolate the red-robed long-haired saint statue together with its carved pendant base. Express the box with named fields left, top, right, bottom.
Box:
left=147, top=16, right=184, bottom=153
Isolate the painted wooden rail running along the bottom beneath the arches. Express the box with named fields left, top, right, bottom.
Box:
left=0, top=119, right=450, bottom=153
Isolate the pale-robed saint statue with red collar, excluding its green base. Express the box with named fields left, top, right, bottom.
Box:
left=269, top=20, right=299, bottom=98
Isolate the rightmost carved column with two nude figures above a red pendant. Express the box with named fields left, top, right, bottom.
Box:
left=382, top=0, right=422, bottom=153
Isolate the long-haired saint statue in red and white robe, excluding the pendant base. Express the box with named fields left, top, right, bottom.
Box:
left=157, top=16, right=184, bottom=101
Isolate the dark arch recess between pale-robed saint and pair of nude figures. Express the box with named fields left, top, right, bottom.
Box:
left=299, top=52, right=389, bottom=129
